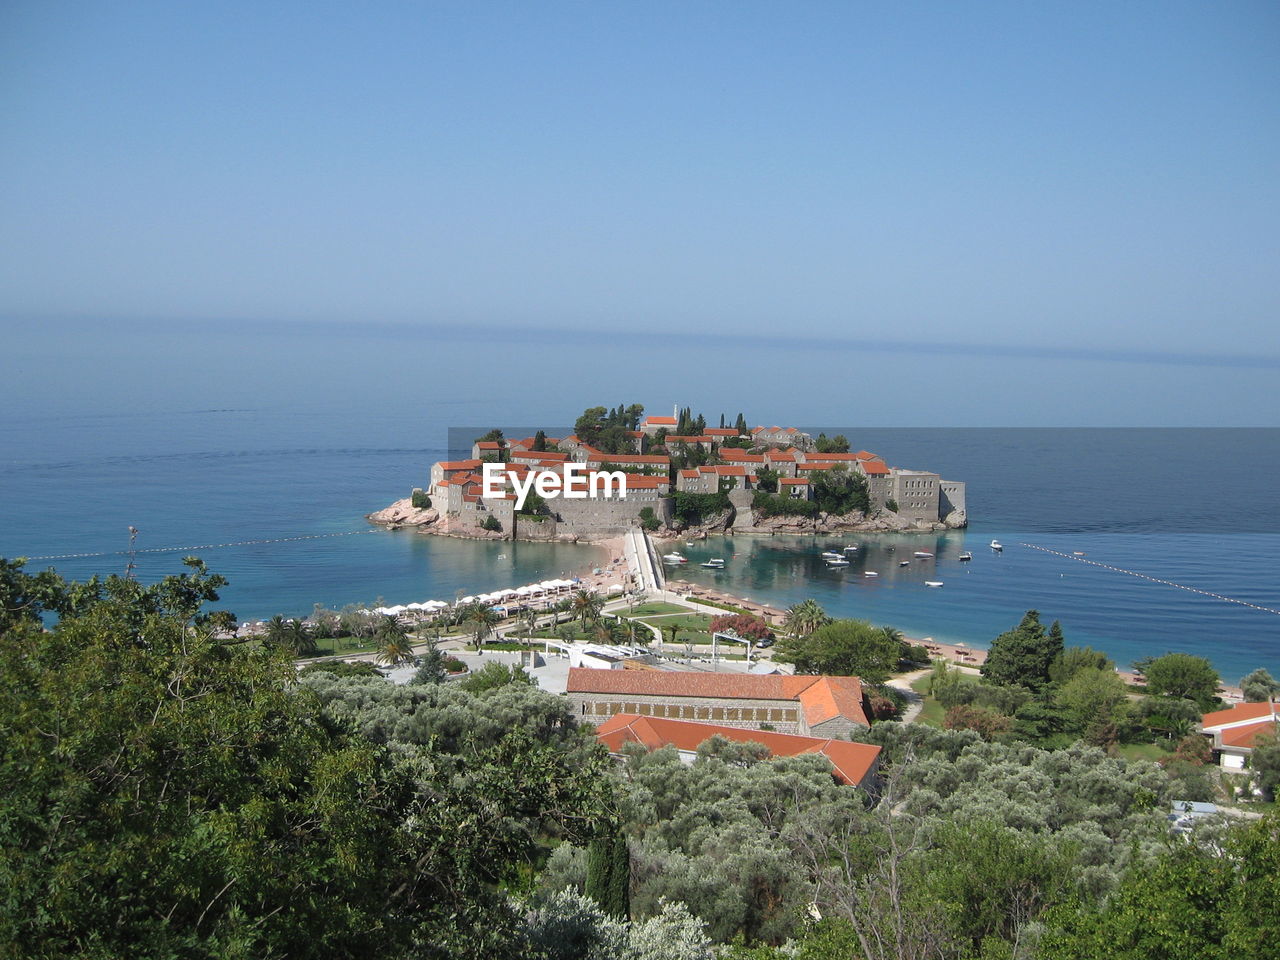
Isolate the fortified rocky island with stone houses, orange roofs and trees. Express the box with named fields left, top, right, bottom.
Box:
left=367, top=404, right=968, bottom=541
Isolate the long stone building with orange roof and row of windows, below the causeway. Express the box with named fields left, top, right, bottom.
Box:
left=567, top=667, right=870, bottom=737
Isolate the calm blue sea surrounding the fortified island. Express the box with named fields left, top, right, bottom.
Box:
left=0, top=323, right=1280, bottom=681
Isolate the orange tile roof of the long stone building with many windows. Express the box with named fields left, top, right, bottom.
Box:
left=568, top=667, right=870, bottom=727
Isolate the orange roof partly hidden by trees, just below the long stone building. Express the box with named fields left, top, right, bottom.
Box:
left=595, top=713, right=881, bottom=786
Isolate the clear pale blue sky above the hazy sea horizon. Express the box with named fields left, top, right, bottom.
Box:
left=0, top=0, right=1280, bottom=421
